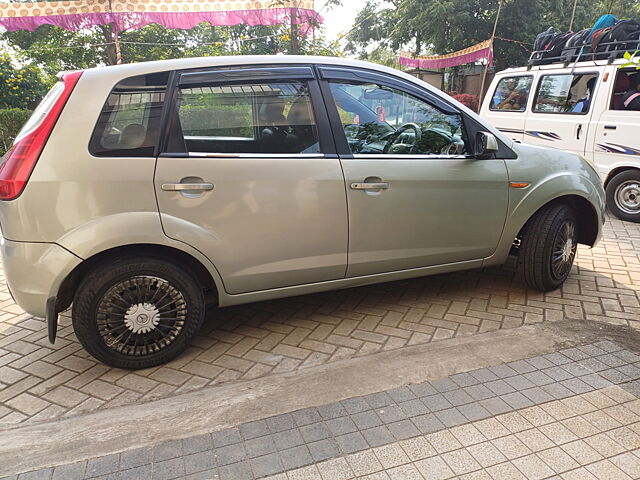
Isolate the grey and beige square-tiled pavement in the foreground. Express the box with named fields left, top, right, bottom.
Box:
left=6, top=341, right=640, bottom=480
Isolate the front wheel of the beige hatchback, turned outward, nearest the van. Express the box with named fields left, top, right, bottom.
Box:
left=518, top=204, right=578, bottom=292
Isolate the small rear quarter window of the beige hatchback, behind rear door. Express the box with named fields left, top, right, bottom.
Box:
left=89, top=72, right=169, bottom=157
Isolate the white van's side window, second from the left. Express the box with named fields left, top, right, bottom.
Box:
left=533, top=73, right=598, bottom=115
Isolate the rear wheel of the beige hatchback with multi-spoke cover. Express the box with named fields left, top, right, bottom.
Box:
left=72, top=257, right=205, bottom=369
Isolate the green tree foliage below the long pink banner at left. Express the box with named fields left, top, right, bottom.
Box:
left=0, top=10, right=339, bottom=74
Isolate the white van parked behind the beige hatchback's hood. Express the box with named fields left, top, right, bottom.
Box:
left=480, top=59, right=640, bottom=222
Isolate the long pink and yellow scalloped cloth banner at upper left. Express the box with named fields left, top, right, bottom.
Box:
left=0, top=0, right=322, bottom=31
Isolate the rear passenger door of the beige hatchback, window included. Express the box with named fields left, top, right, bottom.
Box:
left=155, top=67, right=347, bottom=294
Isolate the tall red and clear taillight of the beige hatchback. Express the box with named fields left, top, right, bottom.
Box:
left=0, top=71, right=82, bottom=200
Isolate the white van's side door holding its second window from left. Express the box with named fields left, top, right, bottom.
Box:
left=524, top=68, right=600, bottom=155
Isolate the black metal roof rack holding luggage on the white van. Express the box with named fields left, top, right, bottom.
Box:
left=527, top=32, right=640, bottom=70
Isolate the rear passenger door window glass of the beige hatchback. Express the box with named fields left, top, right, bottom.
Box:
left=173, top=81, right=320, bottom=154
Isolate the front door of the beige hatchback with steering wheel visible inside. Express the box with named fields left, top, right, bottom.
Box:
left=322, top=68, right=508, bottom=277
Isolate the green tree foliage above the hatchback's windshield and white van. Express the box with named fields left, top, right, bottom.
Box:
left=347, top=0, right=640, bottom=69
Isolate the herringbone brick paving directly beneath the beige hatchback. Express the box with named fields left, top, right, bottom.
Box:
left=0, top=218, right=640, bottom=429
